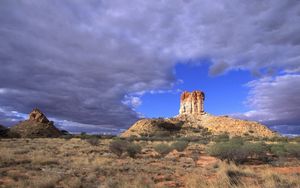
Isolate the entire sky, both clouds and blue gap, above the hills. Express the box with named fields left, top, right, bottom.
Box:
left=0, top=0, right=300, bottom=134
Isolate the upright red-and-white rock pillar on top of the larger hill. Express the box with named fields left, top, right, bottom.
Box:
left=179, top=91, right=205, bottom=115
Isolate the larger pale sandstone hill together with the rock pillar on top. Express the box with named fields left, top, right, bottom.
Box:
left=121, top=91, right=279, bottom=137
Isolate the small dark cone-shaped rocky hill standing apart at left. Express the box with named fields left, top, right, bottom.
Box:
left=9, top=109, right=62, bottom=138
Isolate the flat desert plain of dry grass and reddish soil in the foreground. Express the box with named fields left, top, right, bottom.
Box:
left=0, top=137, right=300, bottom=188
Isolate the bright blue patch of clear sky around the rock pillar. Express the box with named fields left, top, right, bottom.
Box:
left=136, top=62, right=253, bottom=117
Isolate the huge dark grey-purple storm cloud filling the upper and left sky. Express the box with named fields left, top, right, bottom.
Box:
left=0, top=0, right=300, bottom=132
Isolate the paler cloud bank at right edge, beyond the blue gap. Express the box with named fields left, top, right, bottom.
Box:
left=237, top=74, right=300, bottom=134
